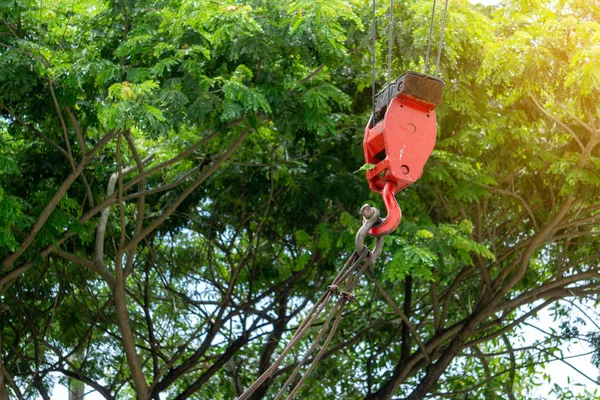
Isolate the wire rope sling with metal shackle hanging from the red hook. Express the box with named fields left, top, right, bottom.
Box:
left=238, top=206, right=382, bottom=400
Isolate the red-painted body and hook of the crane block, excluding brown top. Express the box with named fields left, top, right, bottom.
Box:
left=363, top=90, right=437, bottom=236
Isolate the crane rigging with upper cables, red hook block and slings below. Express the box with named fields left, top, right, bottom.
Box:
left=237, top=0, right=448, bottom=400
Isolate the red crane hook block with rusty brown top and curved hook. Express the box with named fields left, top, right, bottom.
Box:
left=363, top=72, right=444, bottom=237
